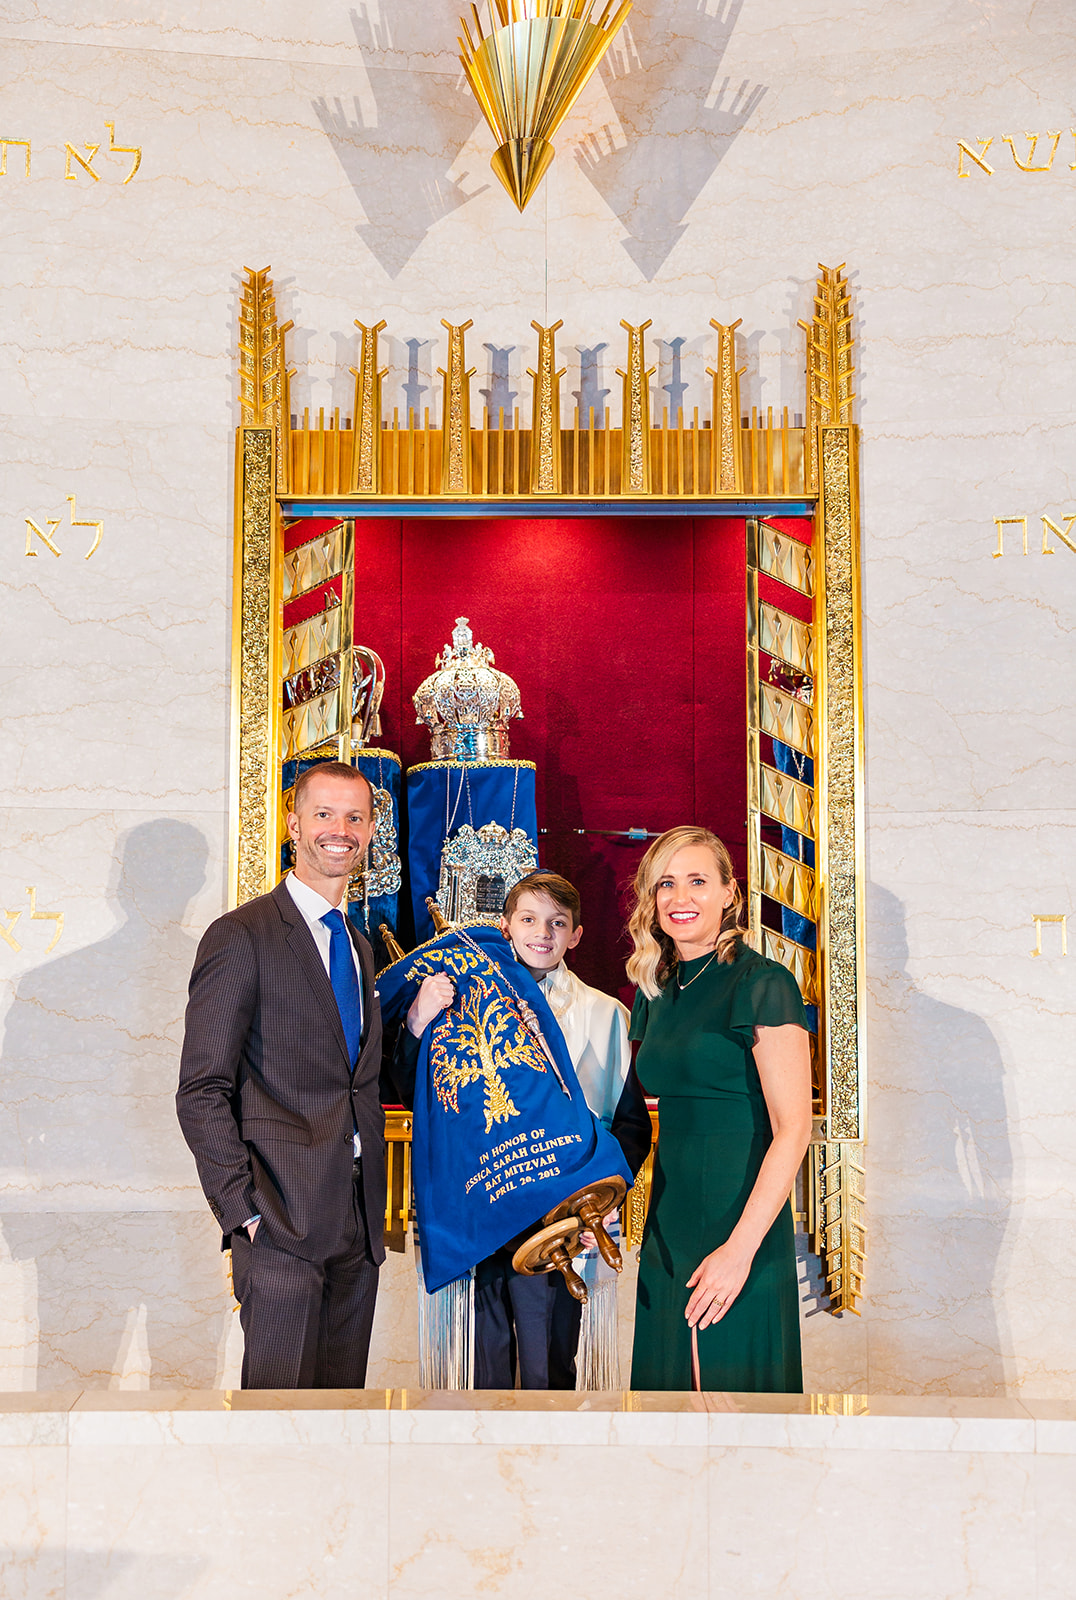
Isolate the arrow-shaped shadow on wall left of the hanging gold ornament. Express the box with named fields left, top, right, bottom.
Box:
left=314, top=0, right=488, bottom=278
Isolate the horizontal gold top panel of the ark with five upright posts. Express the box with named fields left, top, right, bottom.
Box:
left=277, top=318, right=809, bottom=502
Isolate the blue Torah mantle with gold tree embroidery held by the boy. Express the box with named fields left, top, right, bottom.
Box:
left=378, top=926, right=632, bottom=1293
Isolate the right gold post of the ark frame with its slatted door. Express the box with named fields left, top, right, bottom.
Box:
left=748, top=267, right=866, bottom=1310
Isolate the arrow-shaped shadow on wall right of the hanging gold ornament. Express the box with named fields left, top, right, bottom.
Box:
left=576, top=0, right=765, bottom=282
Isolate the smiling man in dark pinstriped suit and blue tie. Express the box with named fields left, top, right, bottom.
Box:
left=176, top=762, right=384, bottom=1389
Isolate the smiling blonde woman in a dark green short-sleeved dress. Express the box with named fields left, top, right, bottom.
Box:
left=628, top=827, right=810, bottom=1394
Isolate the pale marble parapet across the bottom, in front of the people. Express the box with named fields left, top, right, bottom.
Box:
left=0, top=1389, right=1076, bottom=1600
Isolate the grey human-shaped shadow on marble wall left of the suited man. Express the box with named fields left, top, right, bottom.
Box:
left=0, top=819, right=229, bottom=1389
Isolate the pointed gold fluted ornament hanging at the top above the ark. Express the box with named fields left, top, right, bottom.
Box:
left=460, top=0, right=631, bottom=211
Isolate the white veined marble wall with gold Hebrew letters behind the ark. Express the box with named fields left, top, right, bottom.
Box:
left=0, top=0, right=1076, bottom=1395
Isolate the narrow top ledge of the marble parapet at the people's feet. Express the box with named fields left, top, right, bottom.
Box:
left=0, top=1389, right=1076, bottom=1454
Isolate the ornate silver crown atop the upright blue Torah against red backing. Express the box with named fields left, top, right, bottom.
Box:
left=415, top=616, right=524, bottom=762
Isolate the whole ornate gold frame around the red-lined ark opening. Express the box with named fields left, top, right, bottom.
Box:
left=231, top=267, right=866, bottom=1312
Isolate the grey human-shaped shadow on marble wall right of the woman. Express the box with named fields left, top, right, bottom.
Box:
left=868, top=885, right=1012, bottom=1395
